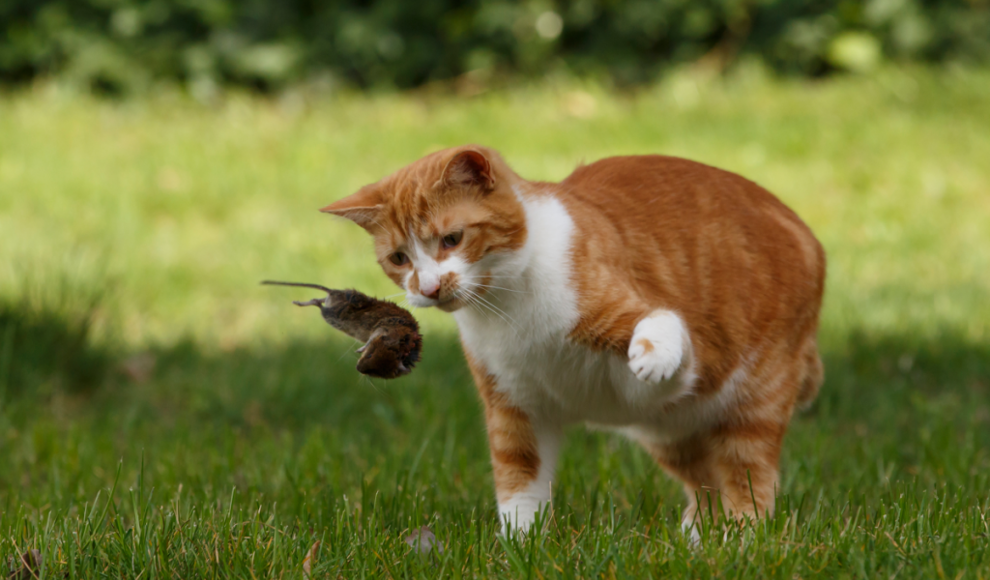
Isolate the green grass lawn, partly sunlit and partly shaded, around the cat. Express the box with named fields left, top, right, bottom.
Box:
left=0, top=65, right=990, bottom=579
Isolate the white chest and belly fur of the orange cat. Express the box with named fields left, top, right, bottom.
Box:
left=454, top=197, right=708, bottom=427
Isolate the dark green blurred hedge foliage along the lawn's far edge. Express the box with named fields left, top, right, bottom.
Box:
left=0, top=0, right=990, bottom=96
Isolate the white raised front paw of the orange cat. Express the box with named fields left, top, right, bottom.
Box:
left=629, top=311, right=686, bottom=384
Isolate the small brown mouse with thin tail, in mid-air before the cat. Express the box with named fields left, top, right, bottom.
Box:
left=262, top=280, right=423, bottom=379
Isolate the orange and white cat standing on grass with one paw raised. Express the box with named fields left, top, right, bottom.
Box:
left=323, top=145, right=825, bottom=534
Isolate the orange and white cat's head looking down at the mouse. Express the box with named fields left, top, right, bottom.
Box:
left=321, top=145, right=526, bottom=312
